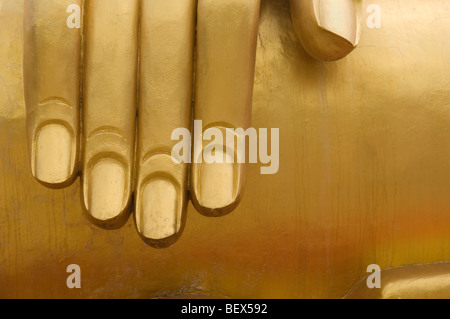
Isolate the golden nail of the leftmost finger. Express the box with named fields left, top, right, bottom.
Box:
left=35, top=124, right=72, bottom=184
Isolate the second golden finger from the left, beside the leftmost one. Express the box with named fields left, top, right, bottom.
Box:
left=82, top=0, right=139, bottom=227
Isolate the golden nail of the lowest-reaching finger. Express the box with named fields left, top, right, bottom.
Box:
left=137, top=178, right=181, bottom=240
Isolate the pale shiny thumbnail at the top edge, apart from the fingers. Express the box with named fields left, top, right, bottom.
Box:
left=314, top=0, right=358, bottom=46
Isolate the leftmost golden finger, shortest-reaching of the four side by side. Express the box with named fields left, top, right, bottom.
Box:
left=23, top=0, right=81, bottom=187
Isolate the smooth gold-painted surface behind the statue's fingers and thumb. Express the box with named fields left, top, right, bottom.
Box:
left=0, top=0, right=450, bottom=298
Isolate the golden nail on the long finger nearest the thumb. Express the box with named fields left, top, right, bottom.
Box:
left=199, top=151, right=235, bottom=209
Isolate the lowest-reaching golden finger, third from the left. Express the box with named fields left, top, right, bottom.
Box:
left=135, top=0, right=197, bottom=247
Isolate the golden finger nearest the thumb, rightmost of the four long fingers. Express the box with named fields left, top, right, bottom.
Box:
left=190, top=0, right=260, bottom=216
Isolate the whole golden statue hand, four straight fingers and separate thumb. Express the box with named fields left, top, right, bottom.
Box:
left=24, top=0, right=359, bottom=247
